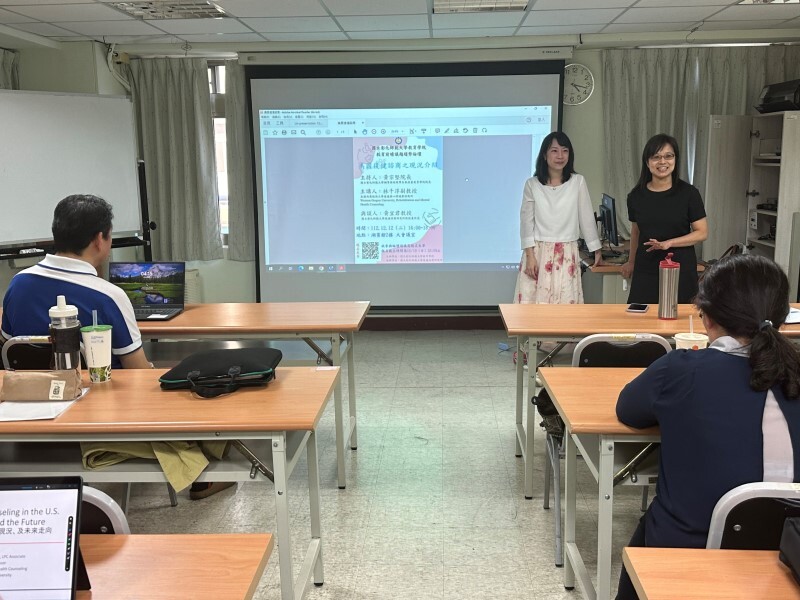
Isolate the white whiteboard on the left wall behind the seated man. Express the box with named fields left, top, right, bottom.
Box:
left=0, top=90, right=142, bottom=247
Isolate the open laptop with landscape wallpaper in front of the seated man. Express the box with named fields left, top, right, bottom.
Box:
left=108, top=262, right=186, bottom=321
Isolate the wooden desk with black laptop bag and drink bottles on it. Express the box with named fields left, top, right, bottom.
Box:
left=0, top=367, right=339, bottom=600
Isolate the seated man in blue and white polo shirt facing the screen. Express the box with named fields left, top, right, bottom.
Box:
left=0, top=195, right=234, bottom=499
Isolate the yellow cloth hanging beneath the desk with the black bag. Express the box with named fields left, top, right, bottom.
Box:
left=81, top=440, right=228, bottom=492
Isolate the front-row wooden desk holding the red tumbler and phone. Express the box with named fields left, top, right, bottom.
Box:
left=500, top=304, right=800, bottom=499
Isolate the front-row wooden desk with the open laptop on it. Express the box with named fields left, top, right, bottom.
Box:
left=139, top=302, right=369, bottom=489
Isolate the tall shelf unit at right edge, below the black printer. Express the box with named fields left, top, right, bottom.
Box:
left=703, top=110, right=800, bottom=298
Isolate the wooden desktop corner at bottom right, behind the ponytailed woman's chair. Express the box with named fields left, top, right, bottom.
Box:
left=622, top=548, right=800, bottom=600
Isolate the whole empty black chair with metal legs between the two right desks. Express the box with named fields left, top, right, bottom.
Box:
left=543, top=333, right=672, bottom=567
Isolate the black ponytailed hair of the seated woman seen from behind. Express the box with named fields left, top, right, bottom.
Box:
left=694, top=254, right=800, bottom=398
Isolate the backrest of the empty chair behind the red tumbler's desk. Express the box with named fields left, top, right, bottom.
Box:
left=572, top=333, right=672, bottom=367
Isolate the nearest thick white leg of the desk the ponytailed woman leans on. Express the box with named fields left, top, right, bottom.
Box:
left=597, top=435, right=614, bottom=600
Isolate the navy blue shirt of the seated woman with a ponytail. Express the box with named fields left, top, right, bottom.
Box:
left=617, top=348, right=800, bottom=548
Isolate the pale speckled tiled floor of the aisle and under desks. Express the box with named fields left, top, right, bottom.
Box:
left=103, top=331, right=641, bottom=600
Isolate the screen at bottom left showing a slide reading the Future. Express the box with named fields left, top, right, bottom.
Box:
left=0, top=477, right=83, bottom=600
